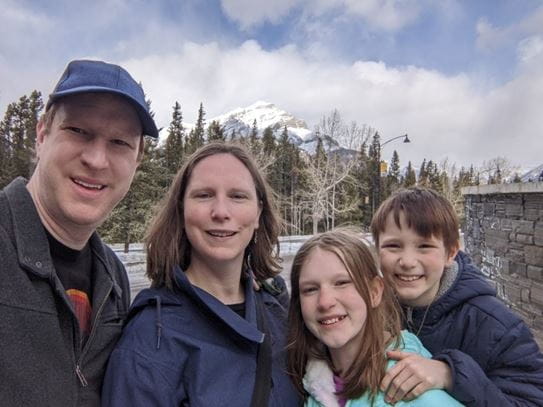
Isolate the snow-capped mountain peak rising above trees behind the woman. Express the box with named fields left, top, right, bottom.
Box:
left=208, top=101, right=312, bottom=146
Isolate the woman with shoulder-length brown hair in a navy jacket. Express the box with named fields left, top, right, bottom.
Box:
left=102, top=143, right=298, bottom=407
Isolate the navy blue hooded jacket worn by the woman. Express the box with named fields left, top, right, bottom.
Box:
left=102, top=268, right=299, bottom=407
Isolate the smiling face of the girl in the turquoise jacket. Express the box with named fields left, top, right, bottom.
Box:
left=300, top=247, right=383, bottom=367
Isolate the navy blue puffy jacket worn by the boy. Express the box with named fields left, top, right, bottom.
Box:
left=404, top=252, right=543, bottom=407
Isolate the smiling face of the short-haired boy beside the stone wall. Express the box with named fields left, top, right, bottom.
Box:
left=378, top=212, right=457, bottom=307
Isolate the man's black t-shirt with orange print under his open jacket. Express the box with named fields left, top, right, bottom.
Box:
left=45, top=230, right=92, bottom=342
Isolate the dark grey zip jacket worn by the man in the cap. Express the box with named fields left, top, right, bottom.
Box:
left=0, top=178, right=130, bottom=407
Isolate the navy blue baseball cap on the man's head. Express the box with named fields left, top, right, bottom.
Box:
left=45, top=60, right=158, bottom=138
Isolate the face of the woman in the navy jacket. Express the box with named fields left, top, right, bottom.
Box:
left=183, top=153, right=261, bottom=269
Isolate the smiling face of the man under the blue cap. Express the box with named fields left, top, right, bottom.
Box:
left=29, top=93, right=142, bottom=234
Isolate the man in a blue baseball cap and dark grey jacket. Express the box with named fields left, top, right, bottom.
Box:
left=0, top=61, right=158, bottom=406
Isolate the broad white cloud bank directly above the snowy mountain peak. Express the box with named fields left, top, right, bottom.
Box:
left=116, top=41, right=543, bottom=170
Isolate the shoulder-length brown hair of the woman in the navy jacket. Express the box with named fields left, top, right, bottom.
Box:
left=145, top=142, right=281, bottom=288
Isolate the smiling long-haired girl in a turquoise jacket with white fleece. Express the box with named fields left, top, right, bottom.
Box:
left=288, top=229, right=460, bottom=407
